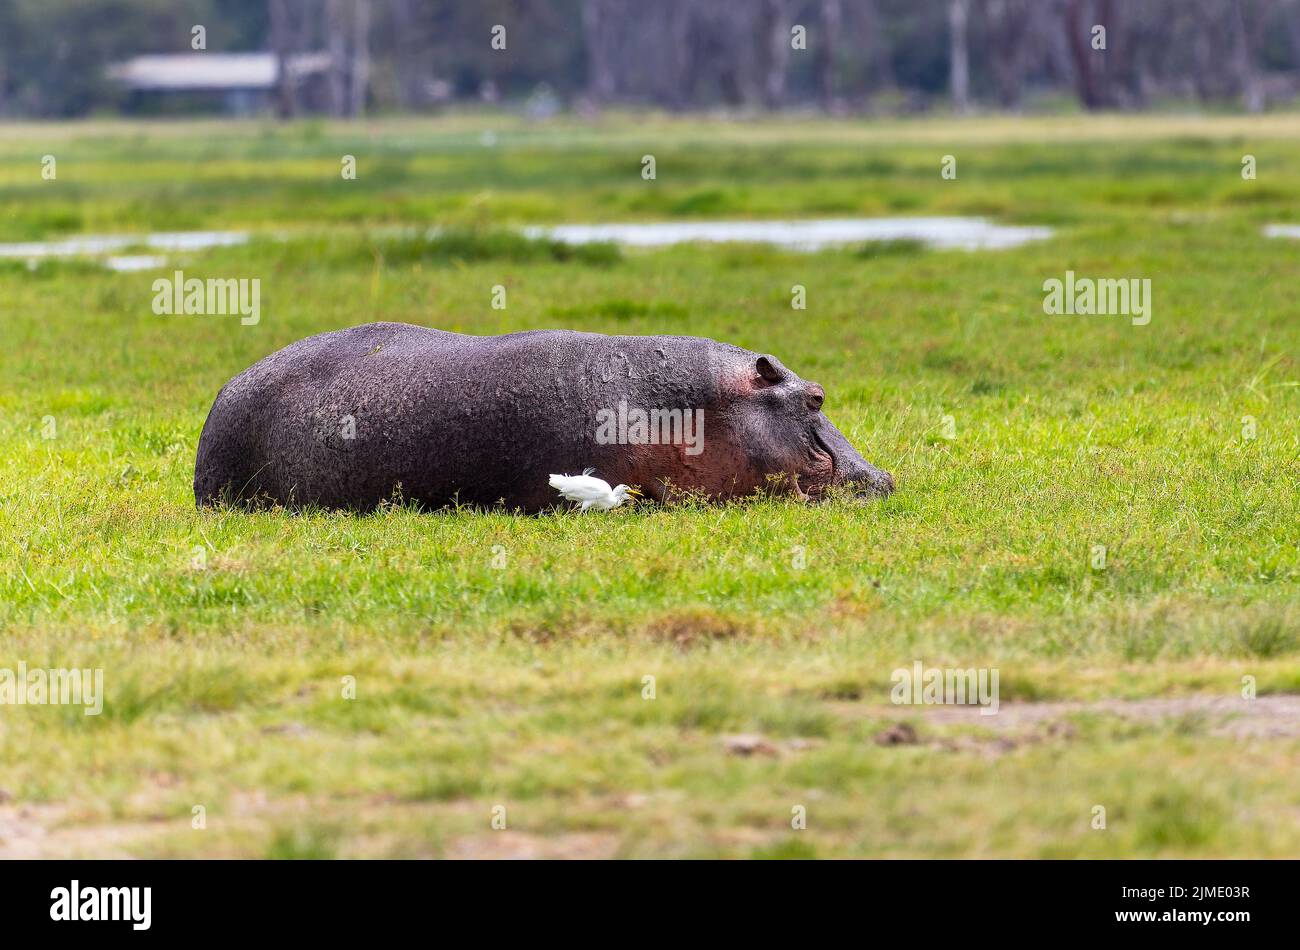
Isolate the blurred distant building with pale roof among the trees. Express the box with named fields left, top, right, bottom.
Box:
left=108, top=52, right=332, bottom=116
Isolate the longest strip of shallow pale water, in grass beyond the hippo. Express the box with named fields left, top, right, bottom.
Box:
left=524, top=217, right=1052, bottom=251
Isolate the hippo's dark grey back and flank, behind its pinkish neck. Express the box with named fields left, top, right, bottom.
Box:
left=194, top=322, right=745, bottom=509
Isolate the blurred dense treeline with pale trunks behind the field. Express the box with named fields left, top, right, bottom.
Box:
left=0, top=0, right=1300, bottom=116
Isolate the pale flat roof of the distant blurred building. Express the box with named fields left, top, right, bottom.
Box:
left=108, top=52, right=330, bottom=91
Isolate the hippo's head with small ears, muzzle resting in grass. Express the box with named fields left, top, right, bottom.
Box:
left=727, top=353, right=894, bottom=498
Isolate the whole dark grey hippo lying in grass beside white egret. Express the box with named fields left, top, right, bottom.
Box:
left=194, top=322, right=893, bottom=513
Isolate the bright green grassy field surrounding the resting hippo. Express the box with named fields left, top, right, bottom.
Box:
left=0, top=116, right=1300, bottom=858
